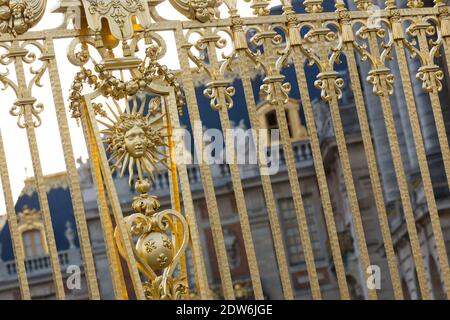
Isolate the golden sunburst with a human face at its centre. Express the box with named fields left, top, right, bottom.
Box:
left=94, top=96, right=169, bottom=186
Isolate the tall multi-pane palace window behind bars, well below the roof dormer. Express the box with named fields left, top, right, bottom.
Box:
left=278, top=198, right=321, bottom=265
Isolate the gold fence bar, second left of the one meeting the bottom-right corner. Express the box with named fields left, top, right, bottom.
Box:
left=344, top=43, right=403, bottom=300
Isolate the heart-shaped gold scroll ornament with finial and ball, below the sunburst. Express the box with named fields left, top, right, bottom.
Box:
left=115, top=180, right=189, bottom=300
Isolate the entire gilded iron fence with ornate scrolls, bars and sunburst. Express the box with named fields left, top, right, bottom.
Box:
left=0, top=0, right=450, bottom=299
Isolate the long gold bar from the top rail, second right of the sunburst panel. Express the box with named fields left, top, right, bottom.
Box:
left=175, top=23, right=235, bottom=300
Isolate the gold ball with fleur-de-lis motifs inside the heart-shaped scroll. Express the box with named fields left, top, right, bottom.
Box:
left=136, top=232, right=174, bottom=271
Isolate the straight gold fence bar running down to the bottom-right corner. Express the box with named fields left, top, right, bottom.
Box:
left=395, top=41, right=450, bottom=298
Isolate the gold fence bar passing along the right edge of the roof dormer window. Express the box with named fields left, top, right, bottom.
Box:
left=292, top=46, right=350, bottom=300
